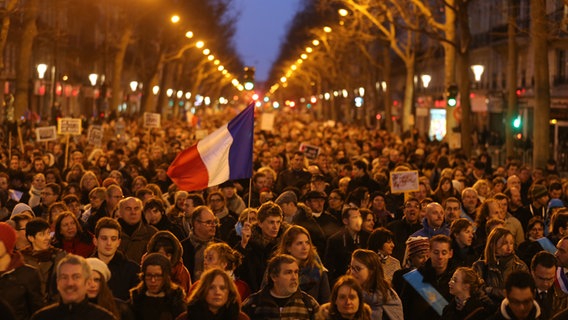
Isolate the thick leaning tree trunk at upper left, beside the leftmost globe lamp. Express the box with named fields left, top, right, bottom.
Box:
left=14, top=0, right=39, bottom=119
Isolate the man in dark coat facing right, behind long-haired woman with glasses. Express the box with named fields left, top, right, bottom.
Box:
left=324, top=207, right=370, bottom=284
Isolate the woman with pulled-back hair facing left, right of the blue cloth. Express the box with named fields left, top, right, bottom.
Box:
left=442, top=267, right=496, bottom=320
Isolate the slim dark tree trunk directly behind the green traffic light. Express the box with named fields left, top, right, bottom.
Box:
left=505, top=0, right=518, bottom=158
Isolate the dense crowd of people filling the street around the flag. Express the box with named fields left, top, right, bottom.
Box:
left=0, top=110, right=568, bottom=320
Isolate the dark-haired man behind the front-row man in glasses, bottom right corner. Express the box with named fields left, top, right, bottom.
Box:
left=531, top=251, right=568, bottom=320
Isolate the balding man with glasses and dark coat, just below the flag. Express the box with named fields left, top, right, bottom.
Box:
left=181, top=206, right=220, bottom=281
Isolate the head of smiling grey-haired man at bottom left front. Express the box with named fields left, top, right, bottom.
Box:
left=57, top=254, right=92, bottom=303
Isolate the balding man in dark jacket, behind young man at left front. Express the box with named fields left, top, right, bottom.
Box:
left=118, top=197, right=158, bottom=263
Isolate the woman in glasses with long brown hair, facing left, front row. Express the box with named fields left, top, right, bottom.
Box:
left=347, top=249, right=404, bottom=320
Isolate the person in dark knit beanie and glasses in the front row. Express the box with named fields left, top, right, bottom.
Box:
left=130, top=253, right=185, bottom=320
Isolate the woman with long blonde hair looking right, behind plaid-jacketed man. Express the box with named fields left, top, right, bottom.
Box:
left=274, top=225, right=330, bottom=304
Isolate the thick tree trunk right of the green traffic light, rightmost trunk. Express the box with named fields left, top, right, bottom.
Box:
left=530, top=0, right=550, bottom=168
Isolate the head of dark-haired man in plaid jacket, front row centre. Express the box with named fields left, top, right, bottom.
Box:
left=266, top=254, right=300, bottom=297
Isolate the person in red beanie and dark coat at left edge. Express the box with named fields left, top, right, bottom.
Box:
left=0, top=222, right=44, bottom=319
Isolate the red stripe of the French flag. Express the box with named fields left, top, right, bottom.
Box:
left=168, top=145, right=209, bottom=191
